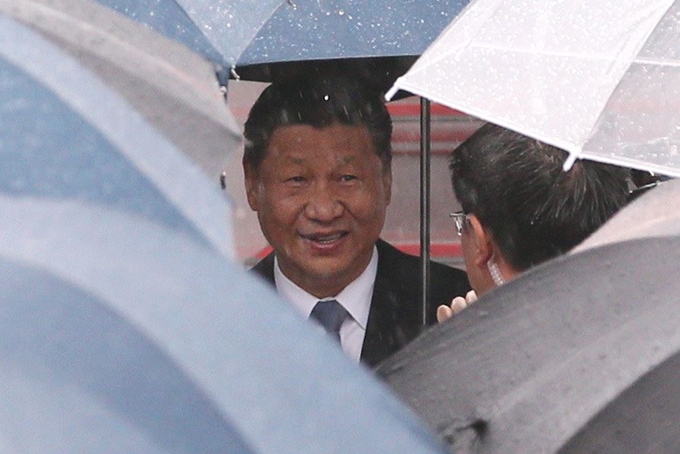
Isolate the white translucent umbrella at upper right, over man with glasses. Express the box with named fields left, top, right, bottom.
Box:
left=388, top=0, right=680, bottom=176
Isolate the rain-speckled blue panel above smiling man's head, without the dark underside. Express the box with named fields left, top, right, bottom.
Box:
left=237, top=0, right=469, bottom=71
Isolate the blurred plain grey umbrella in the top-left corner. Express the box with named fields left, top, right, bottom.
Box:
left=0, top=0, right=241, bottom=184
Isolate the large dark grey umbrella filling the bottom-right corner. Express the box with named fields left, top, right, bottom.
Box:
left=378, top=237, right=680, bottom=453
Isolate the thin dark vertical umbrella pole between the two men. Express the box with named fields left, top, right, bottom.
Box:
left=420, top=98, right=430, bottom=326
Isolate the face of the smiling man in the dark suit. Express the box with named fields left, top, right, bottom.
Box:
left=245, top=124, right=392, bottom=298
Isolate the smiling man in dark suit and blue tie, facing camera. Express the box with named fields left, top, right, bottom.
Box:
left=243, top=78, right=470, bottom=366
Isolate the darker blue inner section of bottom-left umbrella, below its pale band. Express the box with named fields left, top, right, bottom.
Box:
left=0, top=252, right=253, bottom=453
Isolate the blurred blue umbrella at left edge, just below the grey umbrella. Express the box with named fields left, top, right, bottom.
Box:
left=0, top=11, right=233, bottom=256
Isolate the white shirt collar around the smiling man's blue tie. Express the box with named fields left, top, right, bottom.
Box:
left=274, top=246, right=378, bottom=329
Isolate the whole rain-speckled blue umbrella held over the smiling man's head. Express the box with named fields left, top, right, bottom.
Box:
left=97, top=0, right=469, bottom=88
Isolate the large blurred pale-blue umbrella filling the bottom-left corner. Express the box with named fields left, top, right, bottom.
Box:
left=0, top=203, right=441, bottom=453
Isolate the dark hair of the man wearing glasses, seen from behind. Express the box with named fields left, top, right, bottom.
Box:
left=450, top=124, right=628, bottom=270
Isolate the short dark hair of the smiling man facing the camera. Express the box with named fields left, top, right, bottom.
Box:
left=243, top=77, right=392, bottom=170
